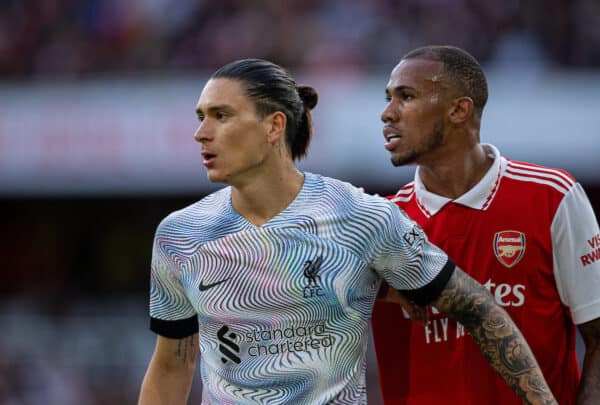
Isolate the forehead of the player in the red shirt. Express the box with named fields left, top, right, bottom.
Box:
left=387, top=59, right=444, bottom=91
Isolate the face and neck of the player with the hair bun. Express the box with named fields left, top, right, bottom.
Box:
left=194, top=79, right=304, bottom=225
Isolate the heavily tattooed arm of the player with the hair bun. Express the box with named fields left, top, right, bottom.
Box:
left=433, top=268, right=556, bottom=404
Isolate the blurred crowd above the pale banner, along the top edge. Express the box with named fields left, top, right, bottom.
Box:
left=0, top=0, right=600, bottom=79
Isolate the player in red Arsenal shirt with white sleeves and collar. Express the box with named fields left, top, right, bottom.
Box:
left=373, top=46, right=600, bottom=405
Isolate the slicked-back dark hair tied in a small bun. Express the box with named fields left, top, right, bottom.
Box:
left=211, top=59, right=319, bottom=160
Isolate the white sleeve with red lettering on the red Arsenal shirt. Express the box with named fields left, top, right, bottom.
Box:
left=550, top=183, right=600, bottom=324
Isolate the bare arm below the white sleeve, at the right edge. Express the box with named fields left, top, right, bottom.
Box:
left=576, top=318, right=600, bottom=405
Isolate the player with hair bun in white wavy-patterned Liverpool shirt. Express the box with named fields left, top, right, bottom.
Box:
left=139, top=59, right=555, bottom=405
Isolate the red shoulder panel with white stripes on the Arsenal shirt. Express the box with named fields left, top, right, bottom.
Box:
left=504, top=159, right=577, bottom=196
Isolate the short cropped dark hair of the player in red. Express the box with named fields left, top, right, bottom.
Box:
left=401, top=45, right=488, bottom=117
